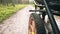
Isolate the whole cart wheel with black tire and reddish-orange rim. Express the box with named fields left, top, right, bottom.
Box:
left=28, top=13, right=46, bottom=34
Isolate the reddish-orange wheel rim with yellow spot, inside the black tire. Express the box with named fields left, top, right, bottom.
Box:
left=28, top=17, right=36, bottom=34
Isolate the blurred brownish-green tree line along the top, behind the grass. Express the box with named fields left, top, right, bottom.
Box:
left=0, top=0, right=29, bottom=6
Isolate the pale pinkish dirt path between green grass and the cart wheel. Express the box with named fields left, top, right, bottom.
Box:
left=0, top=5, right=33, bottom=34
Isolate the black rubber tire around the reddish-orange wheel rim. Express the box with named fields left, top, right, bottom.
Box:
left=30, top=13, right=46, bottom=34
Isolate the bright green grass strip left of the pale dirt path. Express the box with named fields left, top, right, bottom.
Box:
left=0, top=4, right=26, bottom=23
